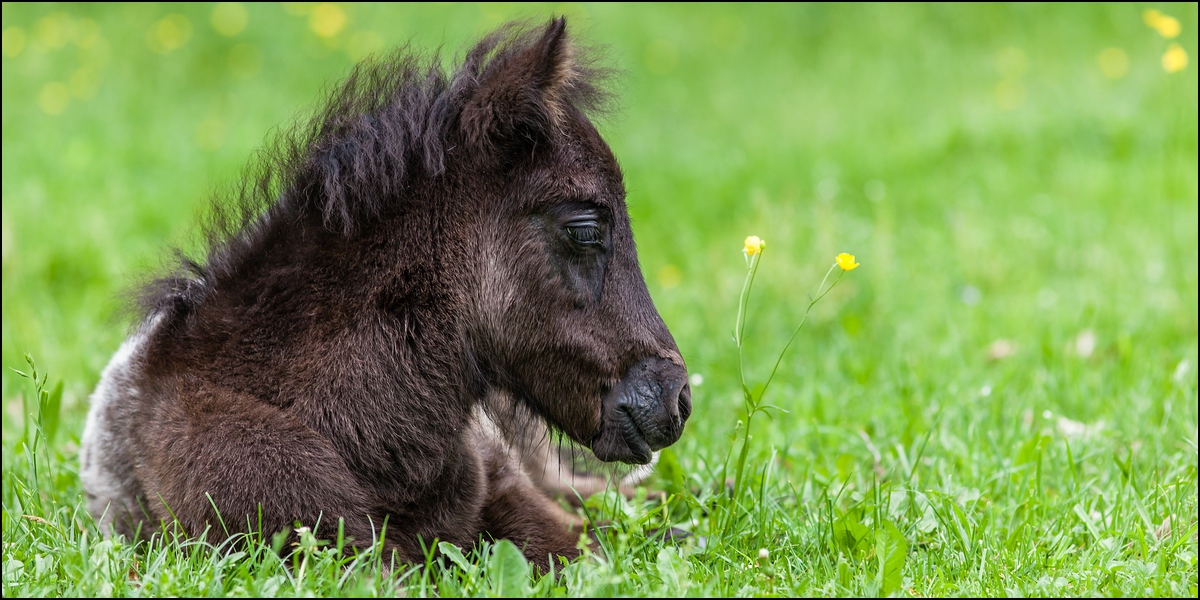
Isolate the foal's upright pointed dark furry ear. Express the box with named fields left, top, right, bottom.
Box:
left=460, top=17, right=576, bottom=151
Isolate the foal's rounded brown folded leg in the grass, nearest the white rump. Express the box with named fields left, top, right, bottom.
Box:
left=139, top=385, right=405, bottom=560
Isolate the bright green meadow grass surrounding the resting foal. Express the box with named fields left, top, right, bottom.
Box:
left=0, top=4, right=1198, bottom=598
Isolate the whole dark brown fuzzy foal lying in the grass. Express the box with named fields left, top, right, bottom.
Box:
left=80, top=19, right=690, bottom=568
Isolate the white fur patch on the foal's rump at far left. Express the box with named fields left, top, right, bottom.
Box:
left=79, top=314, right=162, bottom=533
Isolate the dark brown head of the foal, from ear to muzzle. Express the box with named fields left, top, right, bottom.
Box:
left=445, top=19, right=691, bottom=463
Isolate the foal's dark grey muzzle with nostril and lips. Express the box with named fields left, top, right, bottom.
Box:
left=592, top=358, right=691, bottom=464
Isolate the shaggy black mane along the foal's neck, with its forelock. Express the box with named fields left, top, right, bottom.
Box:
left=136, top=18, right=611, bottom=320
